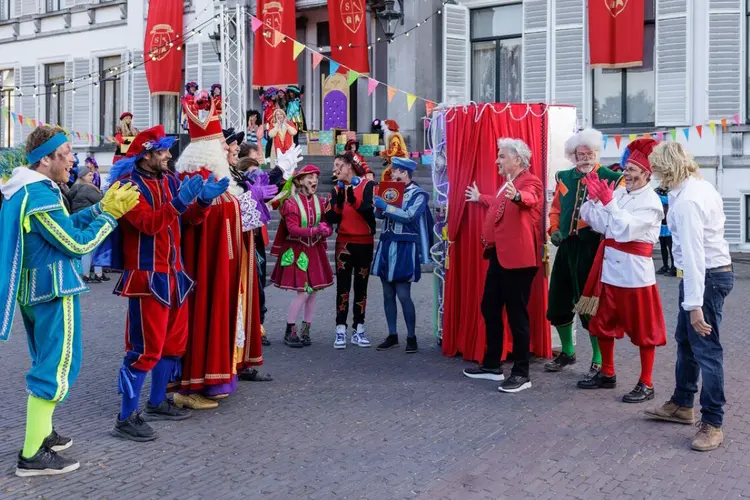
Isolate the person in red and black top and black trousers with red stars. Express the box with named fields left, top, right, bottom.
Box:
left=326, top=153, right=375, bottom=349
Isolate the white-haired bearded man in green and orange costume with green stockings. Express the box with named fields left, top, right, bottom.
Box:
left=544, top=128, right=622, bottom=378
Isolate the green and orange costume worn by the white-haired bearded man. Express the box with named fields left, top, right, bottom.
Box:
left=547, top=165, right=622, bottom=366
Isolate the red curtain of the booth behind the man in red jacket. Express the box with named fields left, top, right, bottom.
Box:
left=442, top=104, right=552, bottom=362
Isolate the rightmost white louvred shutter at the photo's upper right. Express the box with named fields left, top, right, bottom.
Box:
left=708, top=0, right=744, bottom=120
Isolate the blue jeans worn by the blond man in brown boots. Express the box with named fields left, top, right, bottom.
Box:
left=672, top=271, right=734, bottom=427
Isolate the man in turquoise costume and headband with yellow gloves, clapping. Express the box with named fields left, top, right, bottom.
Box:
left=0, top=125, right=138, bottom=477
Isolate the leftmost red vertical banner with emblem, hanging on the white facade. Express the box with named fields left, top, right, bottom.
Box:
left=143, top=0, right=183, bottom=95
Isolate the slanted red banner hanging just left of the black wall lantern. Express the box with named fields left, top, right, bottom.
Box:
left=328, top=0, right=370, bottom=74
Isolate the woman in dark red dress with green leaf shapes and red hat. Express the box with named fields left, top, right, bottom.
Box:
left=271, top=165, right=333, bottom=347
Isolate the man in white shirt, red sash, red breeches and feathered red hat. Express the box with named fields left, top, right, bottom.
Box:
left=576, top=139, right=667, bottom=403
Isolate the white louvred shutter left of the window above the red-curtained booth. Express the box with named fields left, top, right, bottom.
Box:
left=443, top=4, right=471, bottom=104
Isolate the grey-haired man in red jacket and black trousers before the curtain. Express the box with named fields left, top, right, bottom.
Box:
left=464, top=138, right=544, bottom=392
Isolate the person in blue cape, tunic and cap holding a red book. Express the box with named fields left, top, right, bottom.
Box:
left=371, top=157, right=434, bottom=354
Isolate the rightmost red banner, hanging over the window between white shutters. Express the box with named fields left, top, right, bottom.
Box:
left=589, top=0, right=644, bottom=68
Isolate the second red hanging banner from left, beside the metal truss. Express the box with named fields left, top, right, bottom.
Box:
left=253, top=0, right=299, bottom=87
